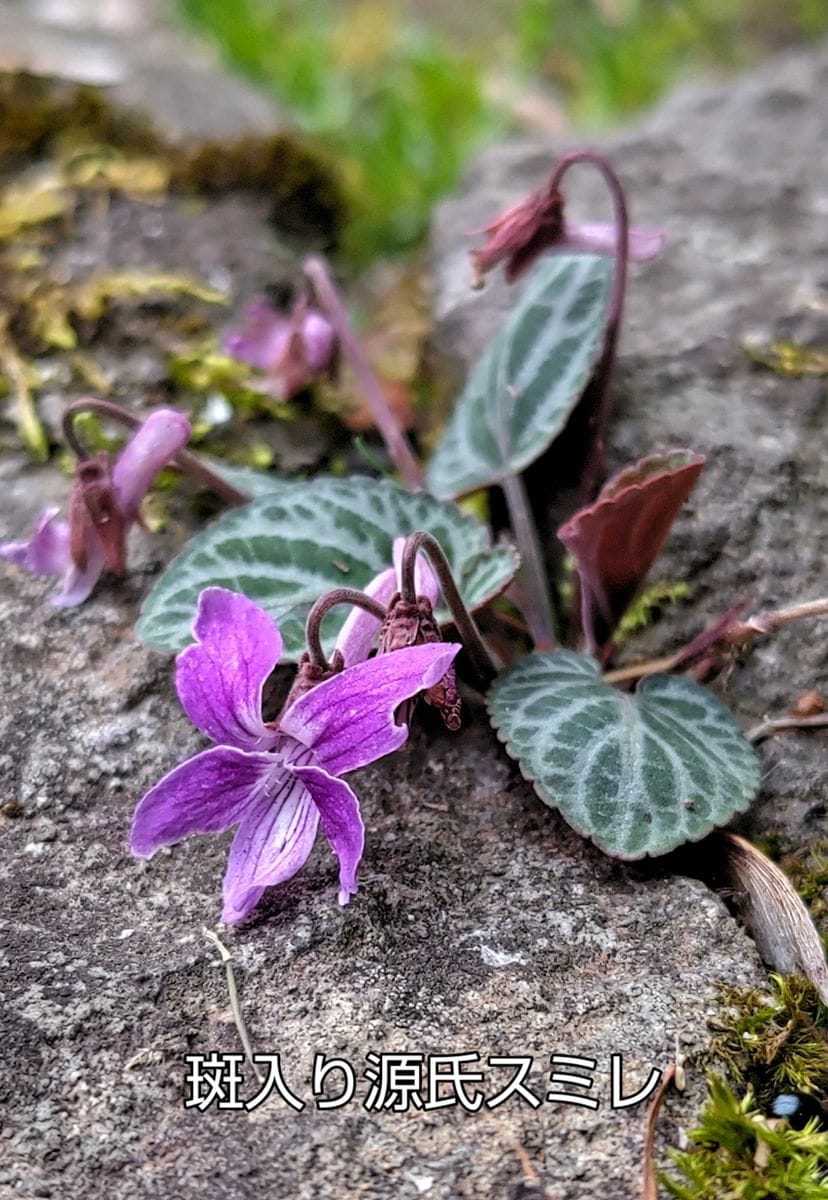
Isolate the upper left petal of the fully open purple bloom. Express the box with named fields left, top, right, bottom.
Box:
left=175, top=588, right=282, bottom=750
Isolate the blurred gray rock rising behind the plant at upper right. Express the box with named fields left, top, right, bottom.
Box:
left=433, top=42, right=828, bottom=848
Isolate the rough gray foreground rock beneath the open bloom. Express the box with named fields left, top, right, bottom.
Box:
left=0, top=540, right=757, bottom=1200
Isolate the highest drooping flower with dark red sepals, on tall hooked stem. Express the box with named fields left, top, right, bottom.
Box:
left=472, top=184, right=665, bottom=284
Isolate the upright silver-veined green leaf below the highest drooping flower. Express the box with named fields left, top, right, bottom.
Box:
left=427, top=254, right=612, bottom=497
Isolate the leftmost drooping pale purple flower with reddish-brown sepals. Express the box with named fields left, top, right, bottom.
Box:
left=0, top=408, right=190, bottom=607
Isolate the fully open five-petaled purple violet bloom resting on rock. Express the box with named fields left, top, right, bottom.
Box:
left=131, top=588, right=460, bottom=924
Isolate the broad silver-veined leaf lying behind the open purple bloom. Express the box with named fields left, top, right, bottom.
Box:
left=137, top=476, right=517, bottom=661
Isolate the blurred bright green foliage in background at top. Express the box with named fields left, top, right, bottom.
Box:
left=178, top=0, right=828, bottom=264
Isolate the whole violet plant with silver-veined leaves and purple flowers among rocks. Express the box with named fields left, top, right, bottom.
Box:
left=0, top=140, right=828, bottom=996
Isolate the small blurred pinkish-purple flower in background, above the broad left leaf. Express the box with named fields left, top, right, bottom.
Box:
left=223, top=300, right=336, bottom=400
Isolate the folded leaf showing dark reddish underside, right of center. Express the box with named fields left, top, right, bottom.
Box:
left=558, top=450, right=704, bottom=646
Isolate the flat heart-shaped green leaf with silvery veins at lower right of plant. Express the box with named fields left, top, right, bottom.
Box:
left=488, top=650, right=760, bottom=859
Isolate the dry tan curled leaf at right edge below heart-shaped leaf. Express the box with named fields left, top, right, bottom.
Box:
left=724, top=833, right=828, bottom=1004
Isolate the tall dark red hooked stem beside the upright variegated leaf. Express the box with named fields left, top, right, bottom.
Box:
left=548, top=150, right=630, bottom=502
